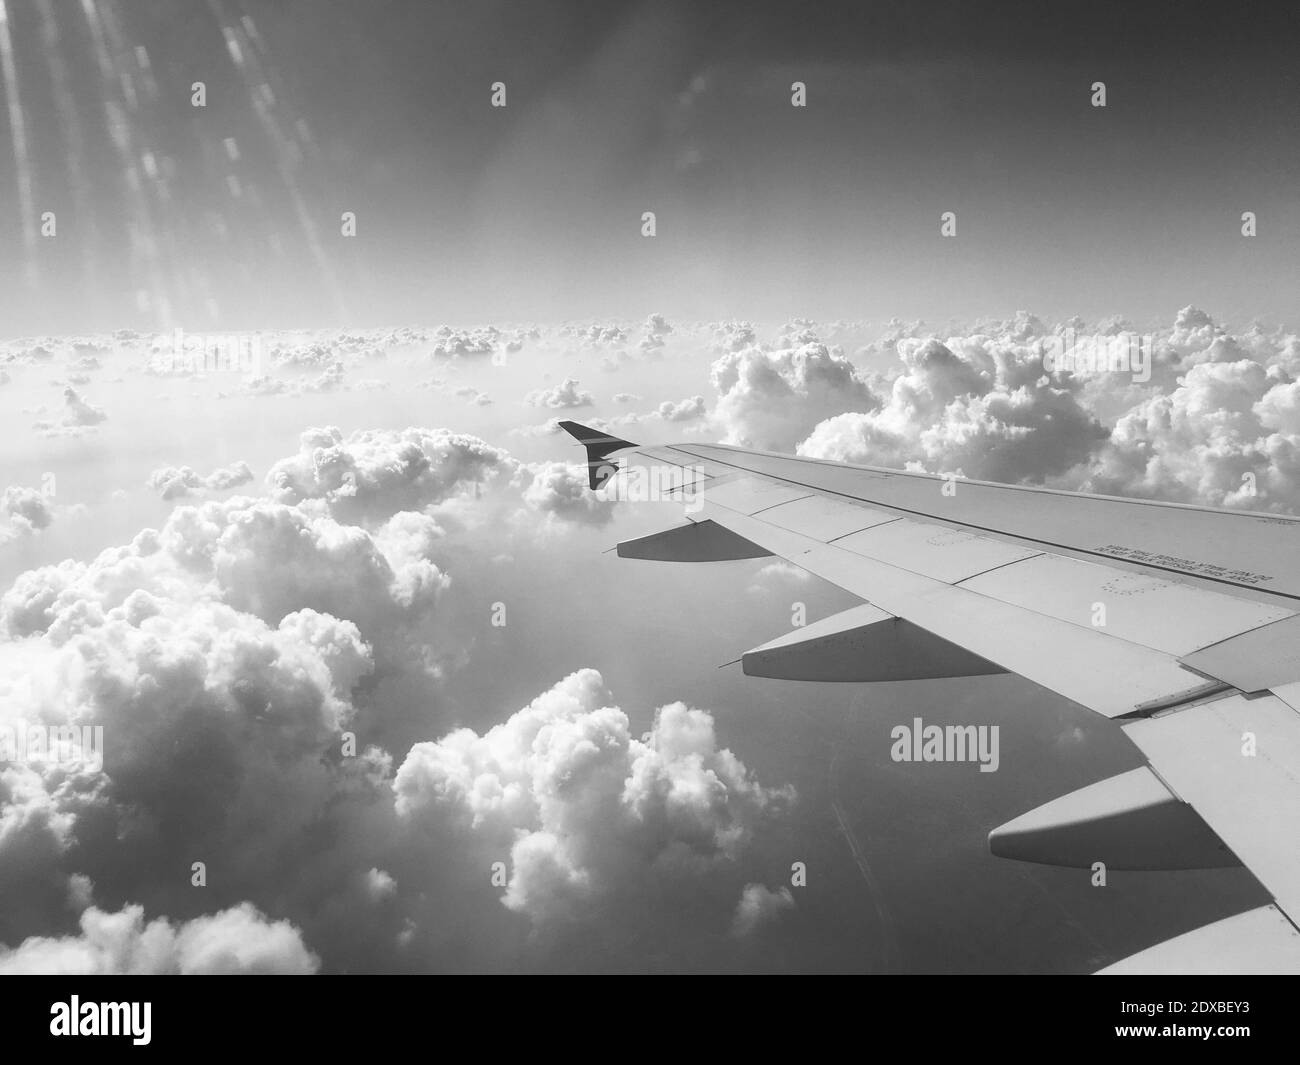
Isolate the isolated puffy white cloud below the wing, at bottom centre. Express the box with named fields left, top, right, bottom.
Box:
left=393, top=670, right=793, bottom=925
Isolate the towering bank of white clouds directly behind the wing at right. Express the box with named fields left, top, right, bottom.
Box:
left=780, top=307, right=1300, bottom=512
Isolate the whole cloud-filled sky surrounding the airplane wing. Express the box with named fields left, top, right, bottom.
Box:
left=0, top=0, right=1300, bottom=973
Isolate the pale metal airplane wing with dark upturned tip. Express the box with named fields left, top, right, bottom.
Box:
left=562, top=423, right=1300, bottom=973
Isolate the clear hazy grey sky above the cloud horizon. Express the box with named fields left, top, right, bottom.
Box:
left=0, top=0, right=1300, bottom=335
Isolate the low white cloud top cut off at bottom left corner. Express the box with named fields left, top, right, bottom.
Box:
left=0, top=902, right=320, bottom=977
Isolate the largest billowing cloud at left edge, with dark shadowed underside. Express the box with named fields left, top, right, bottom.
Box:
left=0, top=470, right=456, bottom=941
